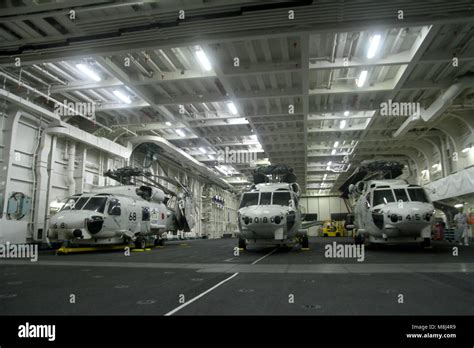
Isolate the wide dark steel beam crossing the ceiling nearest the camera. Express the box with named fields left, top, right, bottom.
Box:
left=0, top=8, right=472, bottom=66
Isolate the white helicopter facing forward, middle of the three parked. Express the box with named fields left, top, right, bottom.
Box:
left=237, top=166, right=317, bottom=249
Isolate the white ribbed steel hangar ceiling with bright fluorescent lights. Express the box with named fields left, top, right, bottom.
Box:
left=0, top=0, right=474, bottom=195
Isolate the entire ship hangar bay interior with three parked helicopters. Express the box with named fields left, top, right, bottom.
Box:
left=0, top=0, right=474, bottom=315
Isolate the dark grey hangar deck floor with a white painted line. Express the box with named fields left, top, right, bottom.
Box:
left=0, top=238, right=474, bottom=315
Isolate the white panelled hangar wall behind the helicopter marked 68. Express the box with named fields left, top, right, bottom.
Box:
left=0, top=109, right=238, bottom=243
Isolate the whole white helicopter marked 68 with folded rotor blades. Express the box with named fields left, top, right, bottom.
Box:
left=48, top=167, right=195, bottom=249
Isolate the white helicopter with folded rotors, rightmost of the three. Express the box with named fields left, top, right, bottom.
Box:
left=340, top=161, right=435, bottom=247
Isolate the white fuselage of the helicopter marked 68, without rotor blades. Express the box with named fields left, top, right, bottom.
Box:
left=48, top=186, right=173, bottom=245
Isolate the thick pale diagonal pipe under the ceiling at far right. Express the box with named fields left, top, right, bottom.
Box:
left=393, top=74, right=474, bottom=138
